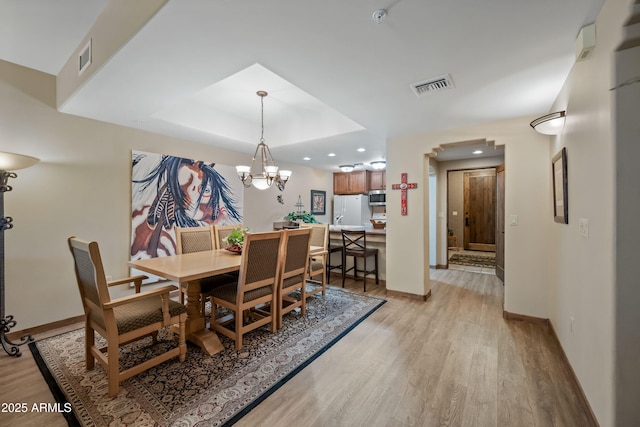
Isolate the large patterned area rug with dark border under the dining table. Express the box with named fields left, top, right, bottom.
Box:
left=29, top=288, right=385, bottom=427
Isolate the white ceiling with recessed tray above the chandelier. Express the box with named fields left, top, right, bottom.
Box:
left=0, top=0, right=604, bottom=170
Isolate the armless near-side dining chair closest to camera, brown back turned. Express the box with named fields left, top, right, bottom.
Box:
left=208, top=231, right=284, bottom=350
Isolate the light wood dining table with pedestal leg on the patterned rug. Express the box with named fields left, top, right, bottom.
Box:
left=129, top=246, right=324, bottom=355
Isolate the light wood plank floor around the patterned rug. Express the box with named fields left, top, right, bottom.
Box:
left=0, top=270, right=590, bottom=427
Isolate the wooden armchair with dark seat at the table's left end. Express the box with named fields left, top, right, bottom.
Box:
left=68, top=237, right=187, bottom=397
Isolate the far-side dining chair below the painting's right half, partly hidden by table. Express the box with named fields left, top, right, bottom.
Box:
left=176, top=225, right=237, bottom=316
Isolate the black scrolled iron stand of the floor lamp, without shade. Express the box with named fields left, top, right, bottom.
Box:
left=0, top=171, right=33, bottom=357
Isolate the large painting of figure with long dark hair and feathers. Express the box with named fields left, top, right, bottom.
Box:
left=131, top=151, right=243, bottom=259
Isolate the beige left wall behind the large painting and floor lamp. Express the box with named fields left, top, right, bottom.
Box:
left=0, top=61, right=333, bottom=330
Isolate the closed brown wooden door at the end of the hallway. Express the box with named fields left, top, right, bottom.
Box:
left=464, top=168, right=496, bottom=252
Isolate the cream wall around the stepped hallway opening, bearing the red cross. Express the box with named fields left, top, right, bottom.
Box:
left=387, top=117, right=553, bottom=318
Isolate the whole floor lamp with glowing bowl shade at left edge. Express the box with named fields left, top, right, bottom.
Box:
left=0, top=152, right=39, bottom=357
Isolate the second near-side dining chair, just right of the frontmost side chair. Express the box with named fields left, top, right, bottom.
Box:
left=277, top=228, right=311, bottom=329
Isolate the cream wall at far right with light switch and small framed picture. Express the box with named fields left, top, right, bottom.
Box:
left=548, top=0, right=638, bottom=426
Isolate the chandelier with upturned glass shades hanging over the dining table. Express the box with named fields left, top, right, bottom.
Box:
left=236, top=90, right=291, bottom=190
